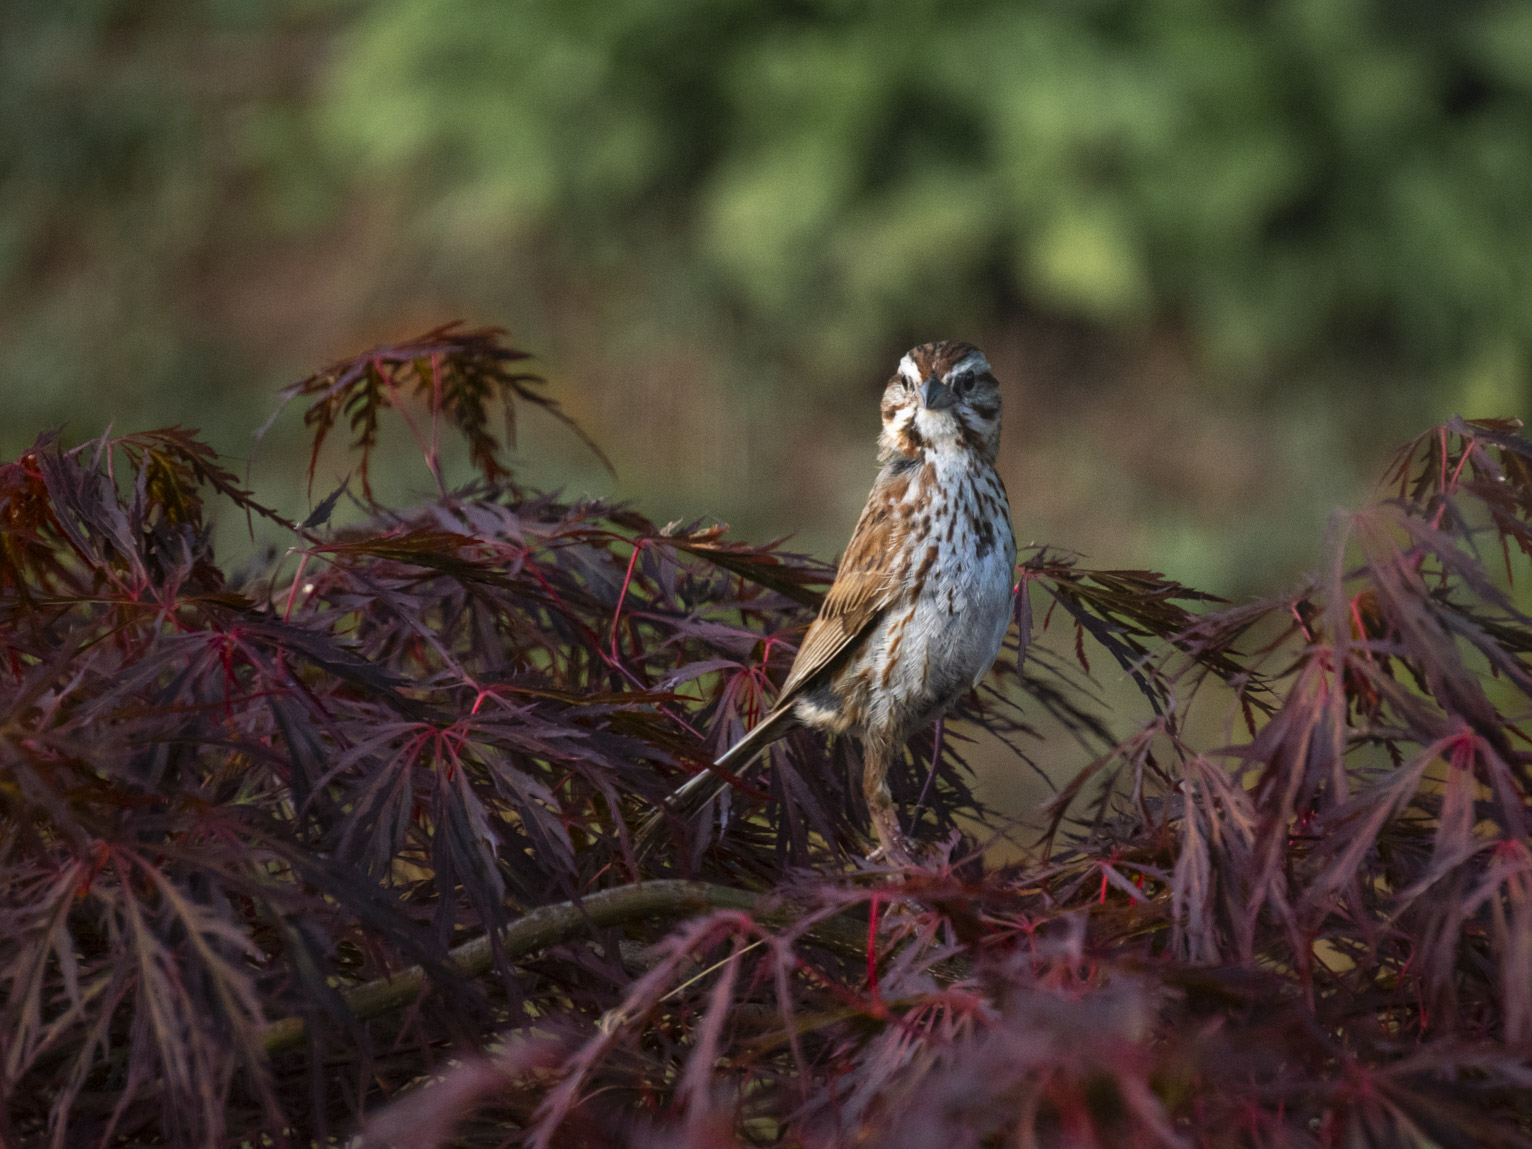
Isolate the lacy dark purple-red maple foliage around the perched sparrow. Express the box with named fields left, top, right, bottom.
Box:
left=0, top=328, right=1532, bottom=1149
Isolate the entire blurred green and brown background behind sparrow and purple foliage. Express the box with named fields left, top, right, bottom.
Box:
left=0, top=0, right=1532, bottom=597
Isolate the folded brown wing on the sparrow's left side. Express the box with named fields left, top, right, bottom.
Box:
left=772, top=476, right=908, bottom=711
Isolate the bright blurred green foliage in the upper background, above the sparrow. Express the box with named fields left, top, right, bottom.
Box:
left=325, top=0, right=1532, bottom=383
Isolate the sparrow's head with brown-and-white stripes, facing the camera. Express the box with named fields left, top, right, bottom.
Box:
left=878, top=340, right=1000, bottom=463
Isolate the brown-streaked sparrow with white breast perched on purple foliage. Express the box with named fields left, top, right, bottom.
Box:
left=652, top=342, right=1016, bottom=859
